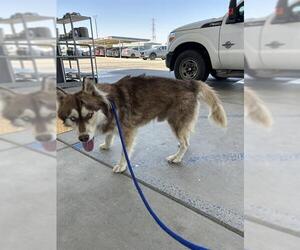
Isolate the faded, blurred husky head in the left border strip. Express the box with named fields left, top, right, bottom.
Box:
left=0, top=78, right=56, bottom=151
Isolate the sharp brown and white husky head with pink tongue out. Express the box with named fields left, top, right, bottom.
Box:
left=57, top=78, right=110, bottom=151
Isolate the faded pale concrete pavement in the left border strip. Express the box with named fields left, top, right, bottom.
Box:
left=0, top=131, right=56, bottom=250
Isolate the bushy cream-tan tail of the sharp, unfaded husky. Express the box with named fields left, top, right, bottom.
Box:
left=197, top=81, right=227, bottom=128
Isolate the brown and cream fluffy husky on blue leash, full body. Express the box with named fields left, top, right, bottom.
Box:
left=57, top=76, right=227, bottom=172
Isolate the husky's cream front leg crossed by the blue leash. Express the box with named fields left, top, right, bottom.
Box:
left=113, top=128, right=136, bottom=173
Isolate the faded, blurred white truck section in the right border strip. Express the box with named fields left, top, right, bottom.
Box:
left=245, top=0, right=300, bottom=78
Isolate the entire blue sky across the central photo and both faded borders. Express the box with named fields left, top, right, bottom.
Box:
left=0, top=0, right=282, bottom=42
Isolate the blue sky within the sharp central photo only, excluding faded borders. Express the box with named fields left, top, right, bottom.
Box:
left=57, top=0, right=228, bottom=42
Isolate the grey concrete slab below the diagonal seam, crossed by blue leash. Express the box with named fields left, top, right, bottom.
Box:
left=57, top=147, right=243, bottom=250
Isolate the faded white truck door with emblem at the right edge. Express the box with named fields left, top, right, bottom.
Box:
left=260, top=2, right=300, bottom=70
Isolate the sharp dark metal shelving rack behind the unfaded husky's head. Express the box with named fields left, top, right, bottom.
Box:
left=56, top=14, right=98, bottom=88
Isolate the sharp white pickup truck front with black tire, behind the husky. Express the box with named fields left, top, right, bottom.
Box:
left=166, top=0, right=244, bottom=81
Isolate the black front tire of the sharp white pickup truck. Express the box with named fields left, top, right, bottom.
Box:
left=174, top=50, right=209, bottom=81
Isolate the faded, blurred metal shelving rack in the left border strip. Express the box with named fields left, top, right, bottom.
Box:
left=0, top=13, right=56, bottom=83
